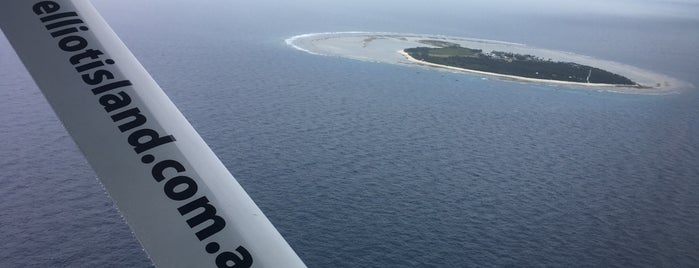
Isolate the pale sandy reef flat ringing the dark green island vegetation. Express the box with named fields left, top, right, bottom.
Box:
left=286, top=32, right=693, bottom=95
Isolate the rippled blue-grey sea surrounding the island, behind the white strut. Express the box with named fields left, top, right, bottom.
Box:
left=0, top=0, right=699, bottom=267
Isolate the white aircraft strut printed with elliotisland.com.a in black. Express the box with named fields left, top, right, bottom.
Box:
left=0, top=0, right=305, bottom=267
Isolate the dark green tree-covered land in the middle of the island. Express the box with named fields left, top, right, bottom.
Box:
left=405, top=40, right=637, bottom=86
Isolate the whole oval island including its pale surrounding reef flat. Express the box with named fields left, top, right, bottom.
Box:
left=286, top=32, right=693, bottom=94
